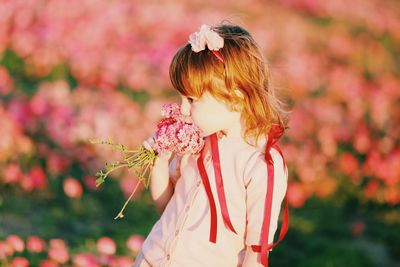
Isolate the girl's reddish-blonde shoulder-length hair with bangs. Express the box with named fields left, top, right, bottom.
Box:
left=169, top=22, right=289, bottom=147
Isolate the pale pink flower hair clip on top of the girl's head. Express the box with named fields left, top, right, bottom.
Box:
left=189, top=24, right=224, bottom=63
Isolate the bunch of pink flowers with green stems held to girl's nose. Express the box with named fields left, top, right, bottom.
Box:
left=90, top=103, right=204, bottom=219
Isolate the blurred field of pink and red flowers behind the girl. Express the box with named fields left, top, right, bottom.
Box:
left=0, top=0, right=400, bottom=267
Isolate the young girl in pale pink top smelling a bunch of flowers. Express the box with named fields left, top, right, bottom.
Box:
left=134, top=24, right=288, bottom=267
